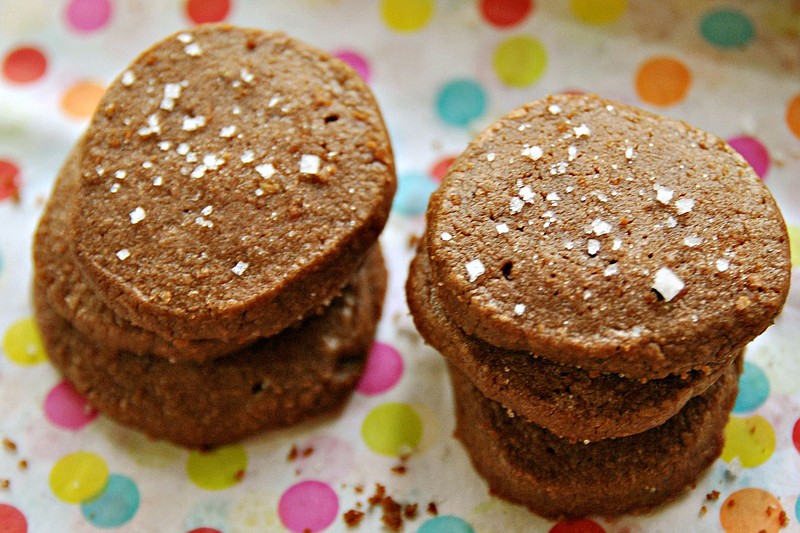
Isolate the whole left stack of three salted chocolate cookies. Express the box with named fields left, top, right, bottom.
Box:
left=33, top=25, right=396, bottom=446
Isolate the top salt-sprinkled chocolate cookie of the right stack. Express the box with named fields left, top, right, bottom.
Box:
left=426, top=95, right=790, bottom=378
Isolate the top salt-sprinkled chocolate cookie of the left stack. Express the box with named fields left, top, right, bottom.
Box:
left=71, top=25, right=396, bottom=339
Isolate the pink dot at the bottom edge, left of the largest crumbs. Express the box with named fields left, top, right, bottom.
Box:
left=278, top=481, right=339, bottom=533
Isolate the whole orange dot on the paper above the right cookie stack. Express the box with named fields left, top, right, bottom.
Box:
left=636, top=57, right=692, bottom=106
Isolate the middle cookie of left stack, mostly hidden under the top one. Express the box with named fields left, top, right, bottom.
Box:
left=33, top=141, right=255, bottom=361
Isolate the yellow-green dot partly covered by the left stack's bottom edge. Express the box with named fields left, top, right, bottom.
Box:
left=186, top=444, right=247, bottom=490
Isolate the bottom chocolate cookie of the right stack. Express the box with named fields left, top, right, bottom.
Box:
left=451, top=356, right=740, bottom=519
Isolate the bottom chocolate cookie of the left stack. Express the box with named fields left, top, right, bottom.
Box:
left=34, top=246, right=386, bottom=447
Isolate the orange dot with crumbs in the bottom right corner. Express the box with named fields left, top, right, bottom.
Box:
left=719, top=489, right=786, bottom=533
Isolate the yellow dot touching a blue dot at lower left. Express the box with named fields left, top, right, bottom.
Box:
left=50, top=452, right=108, bottom=503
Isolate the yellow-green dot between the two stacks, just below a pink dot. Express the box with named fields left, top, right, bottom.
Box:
left=361, top=403, right=422, bottom=457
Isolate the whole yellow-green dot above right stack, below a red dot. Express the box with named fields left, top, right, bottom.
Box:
left=492, top=36, right=547, bottom=87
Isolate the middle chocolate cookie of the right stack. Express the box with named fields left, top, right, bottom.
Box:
left=406, top=244, right=742, bottom=442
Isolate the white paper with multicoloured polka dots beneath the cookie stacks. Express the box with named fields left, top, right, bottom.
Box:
left=0, top=0, right=800, bottom=533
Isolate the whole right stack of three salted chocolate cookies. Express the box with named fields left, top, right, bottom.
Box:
left=407, top=95, right=790, bottom=518
